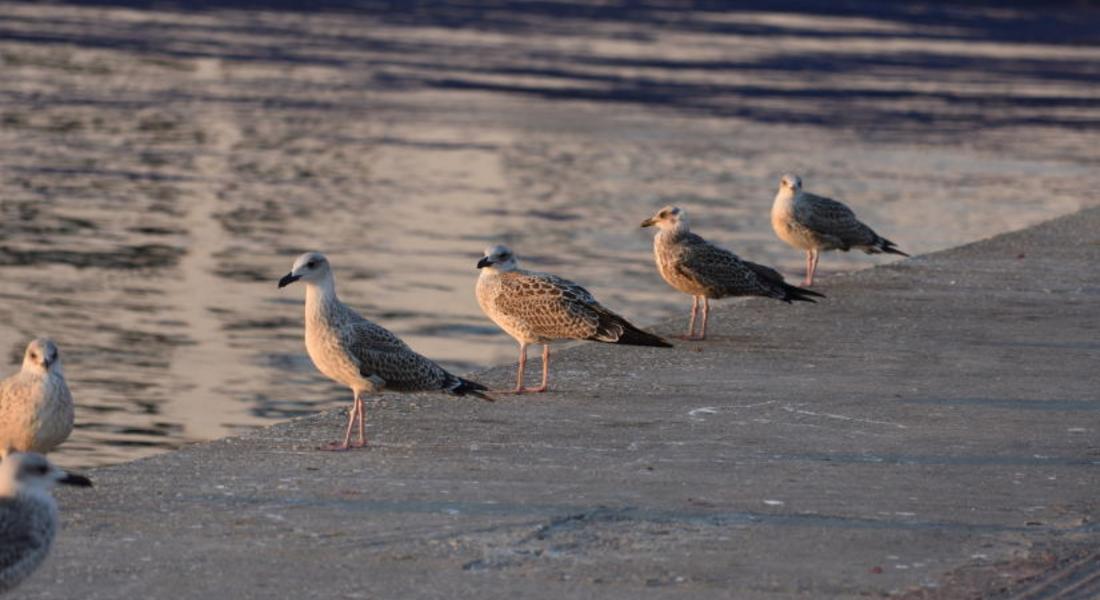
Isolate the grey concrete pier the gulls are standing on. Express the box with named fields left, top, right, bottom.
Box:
left=17, top=208, right=1100, bottom=600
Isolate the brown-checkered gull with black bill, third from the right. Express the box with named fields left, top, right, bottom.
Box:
left=476, top=246, right=672, bottom=394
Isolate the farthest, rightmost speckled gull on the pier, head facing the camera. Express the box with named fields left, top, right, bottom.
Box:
left=771, top=173, right=909, bottom=285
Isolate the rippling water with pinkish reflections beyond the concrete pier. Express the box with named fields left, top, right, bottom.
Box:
left=0, top=3, right=1100, bottom=466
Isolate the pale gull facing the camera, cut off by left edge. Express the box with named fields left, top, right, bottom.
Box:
left=0, top=338, right=73, bottom=454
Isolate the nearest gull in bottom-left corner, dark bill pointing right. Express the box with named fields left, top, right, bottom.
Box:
left=0, top=451, right=91, bottom=593
